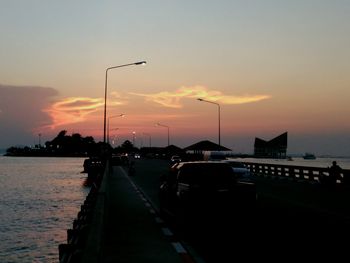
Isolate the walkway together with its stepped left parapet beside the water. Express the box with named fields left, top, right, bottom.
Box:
left=59, top=161, right=193, bottom=263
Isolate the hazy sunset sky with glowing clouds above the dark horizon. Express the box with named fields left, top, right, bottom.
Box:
left=0, top=0, right=350, bottom=156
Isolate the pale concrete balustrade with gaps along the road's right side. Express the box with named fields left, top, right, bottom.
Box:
left=244, top=162, right=350, bottom=185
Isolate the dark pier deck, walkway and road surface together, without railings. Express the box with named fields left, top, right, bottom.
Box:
left=62, top=160, right=350, bottom=263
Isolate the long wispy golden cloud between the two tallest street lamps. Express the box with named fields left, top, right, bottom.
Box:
left=130, top=86, right=271, bottom=108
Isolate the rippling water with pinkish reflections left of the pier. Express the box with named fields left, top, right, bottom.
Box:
left=0, top=156, right=90, bottom=263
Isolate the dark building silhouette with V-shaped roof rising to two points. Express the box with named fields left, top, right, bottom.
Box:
left=254, top=132, right=287, bottom=159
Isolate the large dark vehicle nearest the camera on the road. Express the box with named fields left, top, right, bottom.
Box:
left=159, top=161, right=256, bottom=226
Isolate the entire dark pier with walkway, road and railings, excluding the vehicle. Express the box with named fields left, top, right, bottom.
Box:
left=59, top=159, right=350, bottom=263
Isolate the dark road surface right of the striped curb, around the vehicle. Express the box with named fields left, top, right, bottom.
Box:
left=130, top=159, right=350, bottom=262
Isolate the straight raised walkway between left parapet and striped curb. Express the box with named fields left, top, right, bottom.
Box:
left=82, top=166, right=193, bottom=263
